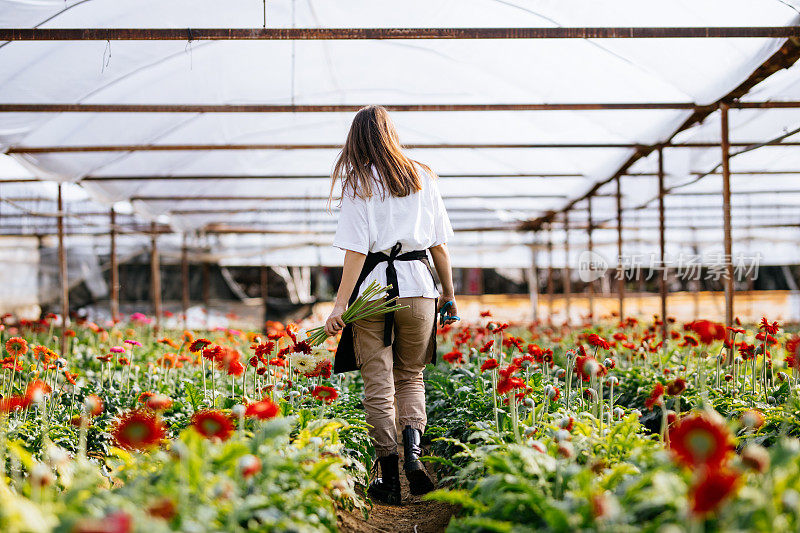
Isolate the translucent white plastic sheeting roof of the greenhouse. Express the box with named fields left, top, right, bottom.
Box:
left=0, top=0, right=800, bottom=266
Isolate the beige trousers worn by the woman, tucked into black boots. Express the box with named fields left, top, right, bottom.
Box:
left=353, top=297, right=436, bottom=457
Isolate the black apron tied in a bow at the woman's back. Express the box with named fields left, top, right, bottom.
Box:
left=333, top=242, right=438, bottom=374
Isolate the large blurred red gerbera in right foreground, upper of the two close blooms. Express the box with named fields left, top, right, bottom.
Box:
left=669, top=413, right=733, bottom=469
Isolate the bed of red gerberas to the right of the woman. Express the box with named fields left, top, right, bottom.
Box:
left=428, top=313, right=800, bottom=531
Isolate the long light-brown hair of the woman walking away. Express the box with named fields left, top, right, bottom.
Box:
left=328, top=105, right=434, bottom=207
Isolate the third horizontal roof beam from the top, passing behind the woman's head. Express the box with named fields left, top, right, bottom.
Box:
left=6, top=141, right=800, bottom=154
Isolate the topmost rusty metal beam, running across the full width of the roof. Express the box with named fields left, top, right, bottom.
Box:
left=0, top=26, right=800, bottom=41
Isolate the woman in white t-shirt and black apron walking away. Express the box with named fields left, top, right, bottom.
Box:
left=325, top=106, right=457, bottom=504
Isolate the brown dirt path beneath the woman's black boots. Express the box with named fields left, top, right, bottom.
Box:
left=338, top=450, right=456, bottom=533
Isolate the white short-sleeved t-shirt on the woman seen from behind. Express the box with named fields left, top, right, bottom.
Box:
left=333, top=168, right=453, bottom=298
